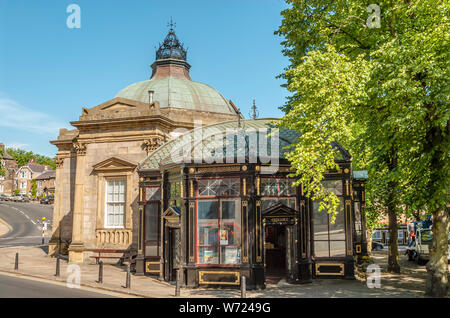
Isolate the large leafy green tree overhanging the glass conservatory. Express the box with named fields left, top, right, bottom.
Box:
left=276, top=0, right=450, bottom=296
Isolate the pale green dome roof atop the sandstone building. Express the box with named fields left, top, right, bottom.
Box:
left=116, top=76, right=236, bottom=115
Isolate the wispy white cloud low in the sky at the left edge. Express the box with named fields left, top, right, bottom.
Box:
left=0, top=92, right=67, bottom=135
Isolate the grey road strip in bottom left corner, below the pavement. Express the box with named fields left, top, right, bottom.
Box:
left=0, top=274, right=114, bottom=298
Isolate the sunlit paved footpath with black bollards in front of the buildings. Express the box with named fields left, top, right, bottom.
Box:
left=0, top=246, right=442, bottom=298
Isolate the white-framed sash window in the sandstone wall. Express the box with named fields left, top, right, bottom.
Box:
left=105, top=179, right=126, bottom=228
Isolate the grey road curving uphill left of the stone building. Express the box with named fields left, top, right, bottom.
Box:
left=0, top=201, right=53, bottom=248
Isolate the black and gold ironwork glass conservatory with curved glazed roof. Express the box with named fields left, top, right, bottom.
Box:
left=136, top=119, right=367, bottom=289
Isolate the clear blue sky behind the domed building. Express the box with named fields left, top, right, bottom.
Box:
left=0, top=0, right=289, bottom=157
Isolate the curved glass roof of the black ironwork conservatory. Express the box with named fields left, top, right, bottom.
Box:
left=139, top=118, right=300, bottom=170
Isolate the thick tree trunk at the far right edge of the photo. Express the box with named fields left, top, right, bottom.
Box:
left=426, top=210, right=449, bottom=297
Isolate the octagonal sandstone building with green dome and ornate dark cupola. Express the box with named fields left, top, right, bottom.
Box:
left=50, top=29, right=242, bottom=262
